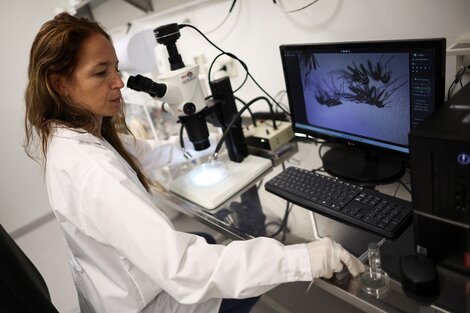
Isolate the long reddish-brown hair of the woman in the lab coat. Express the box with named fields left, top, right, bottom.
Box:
left=23, top=13, right=149, bottom=191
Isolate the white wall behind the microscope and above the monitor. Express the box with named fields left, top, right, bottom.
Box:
left=95, top=0, right=470, bottom=110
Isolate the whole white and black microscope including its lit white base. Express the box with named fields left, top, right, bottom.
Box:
left=127, top=24, right=272, bottom=210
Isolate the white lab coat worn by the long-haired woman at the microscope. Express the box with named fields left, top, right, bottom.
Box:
left=46, top=127, right=312, bottom=313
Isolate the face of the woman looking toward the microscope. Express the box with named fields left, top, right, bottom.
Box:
left=60, top=34, right=124, bottom=118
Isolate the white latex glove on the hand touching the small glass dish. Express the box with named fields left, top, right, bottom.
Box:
left=307, top=237, right=365, bottom=278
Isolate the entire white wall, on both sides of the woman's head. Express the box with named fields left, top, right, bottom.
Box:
left=0, top=0, right=470, bottom=231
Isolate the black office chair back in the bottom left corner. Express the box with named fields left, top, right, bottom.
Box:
left=0, top=225, right=58, bottom=313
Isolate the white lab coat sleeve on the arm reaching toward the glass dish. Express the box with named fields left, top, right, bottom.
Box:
left=80, top=157, right=312, bottom=304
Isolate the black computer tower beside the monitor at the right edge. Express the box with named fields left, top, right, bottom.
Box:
left=410, top=84, right=470, bottom=275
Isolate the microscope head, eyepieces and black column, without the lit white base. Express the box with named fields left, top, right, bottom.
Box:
left=127, top=23, right=248, bottom=162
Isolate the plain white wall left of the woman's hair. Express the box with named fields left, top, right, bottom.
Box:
left=0, top=0, right=67, bottom=231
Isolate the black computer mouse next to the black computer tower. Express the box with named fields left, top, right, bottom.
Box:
left=400, top=255, right=440, bottom=304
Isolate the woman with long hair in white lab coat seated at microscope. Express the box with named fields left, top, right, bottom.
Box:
left=25, top=13, right=363, bottom=313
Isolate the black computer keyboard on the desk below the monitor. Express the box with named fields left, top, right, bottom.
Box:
left=265, top=166, right=411, bottom=238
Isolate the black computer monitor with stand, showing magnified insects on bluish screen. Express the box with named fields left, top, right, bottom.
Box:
left=280, top=38, right=446, bottom=183
